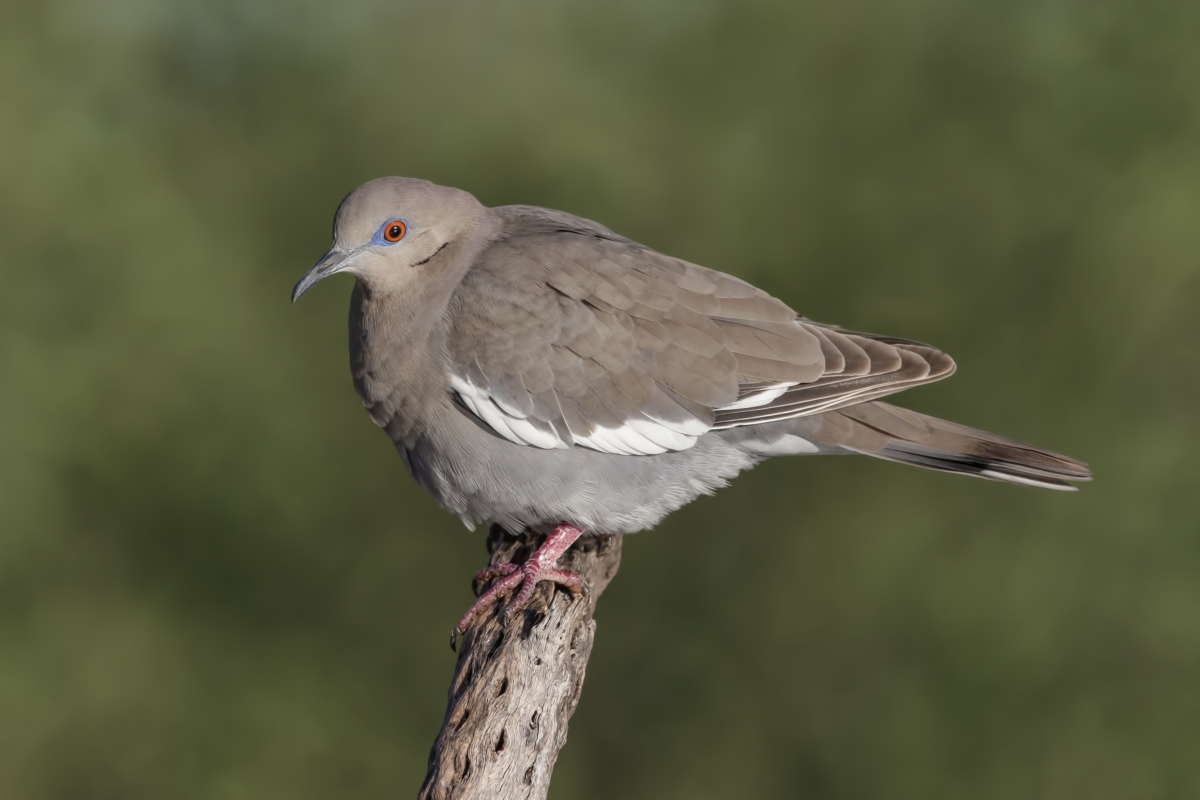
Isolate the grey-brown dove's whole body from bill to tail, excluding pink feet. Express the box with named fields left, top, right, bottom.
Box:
left=293, top=178, right=1091, bottom=534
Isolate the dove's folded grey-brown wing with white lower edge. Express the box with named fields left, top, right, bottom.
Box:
left=446, top=206, right=954, bottom=456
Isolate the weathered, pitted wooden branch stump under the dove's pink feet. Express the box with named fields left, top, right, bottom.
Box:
left=419, top=525, right=620, bottom=800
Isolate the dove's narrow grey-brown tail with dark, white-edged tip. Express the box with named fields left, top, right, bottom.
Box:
left=793, top=402, right=1092, bottom=492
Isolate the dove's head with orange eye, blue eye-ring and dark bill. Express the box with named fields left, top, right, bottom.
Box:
left=292, top=178, right=487, bottom=302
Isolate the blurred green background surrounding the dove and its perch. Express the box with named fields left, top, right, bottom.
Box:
left=0, top=0, right=1200, bottom=800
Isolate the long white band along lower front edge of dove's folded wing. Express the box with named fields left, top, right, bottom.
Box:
left=450, top=373, right=709, bottom=456
